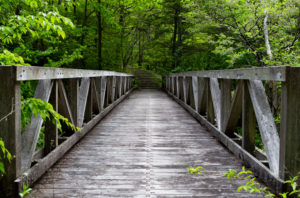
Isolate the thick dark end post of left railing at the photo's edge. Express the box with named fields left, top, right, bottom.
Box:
left=0, top=66, right=21, bottom=197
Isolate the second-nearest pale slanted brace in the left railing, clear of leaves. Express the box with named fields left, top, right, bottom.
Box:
left=77, top=78, right=90, bottom=127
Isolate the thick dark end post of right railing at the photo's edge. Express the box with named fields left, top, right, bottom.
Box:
left=279, top=67, right=300, bottom=179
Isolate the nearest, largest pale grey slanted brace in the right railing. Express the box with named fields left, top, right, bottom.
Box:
left=247, top=80, right=279, bottom=176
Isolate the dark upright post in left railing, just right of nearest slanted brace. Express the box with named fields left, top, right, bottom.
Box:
left=44, top=80, right=59, bottom=155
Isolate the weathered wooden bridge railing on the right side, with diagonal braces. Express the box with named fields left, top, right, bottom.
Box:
left=163, top=67, right=300, bottom=192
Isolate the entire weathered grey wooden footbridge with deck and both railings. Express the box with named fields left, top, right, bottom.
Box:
left=0, top=66, right=300, bottom=197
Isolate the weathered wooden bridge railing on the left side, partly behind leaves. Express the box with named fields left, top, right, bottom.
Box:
left=0, top=66, right=133, bottom=197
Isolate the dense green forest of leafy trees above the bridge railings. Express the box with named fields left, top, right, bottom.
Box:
left=0, top=0, right=300, bottom=74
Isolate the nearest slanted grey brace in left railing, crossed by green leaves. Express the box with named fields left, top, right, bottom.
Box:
left=22, top=80, right=53, bottom=172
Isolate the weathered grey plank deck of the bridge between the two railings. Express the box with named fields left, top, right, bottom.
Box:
left=31, top=90, right=263, bottom=198
